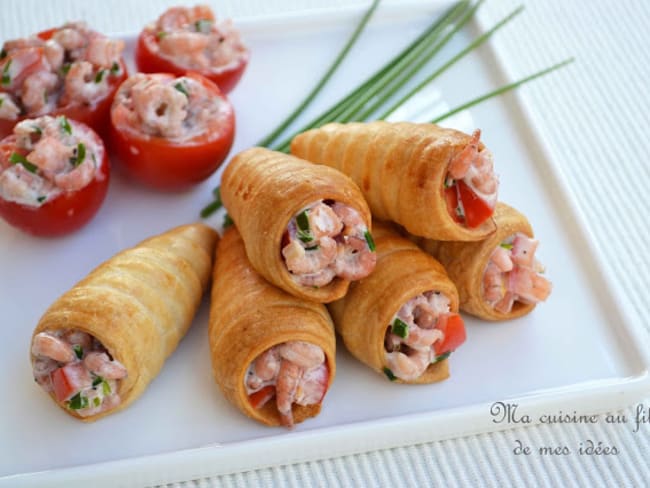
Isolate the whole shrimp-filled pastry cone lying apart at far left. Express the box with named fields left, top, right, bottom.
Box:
left=31, top=224, right=218, bottom=422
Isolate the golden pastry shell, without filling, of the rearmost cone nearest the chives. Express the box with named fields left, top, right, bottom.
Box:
left=291, top=121, right=495, bottom=241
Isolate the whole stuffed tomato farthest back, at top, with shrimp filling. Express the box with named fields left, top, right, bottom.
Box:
left=135, top=5, right=249, bottom=93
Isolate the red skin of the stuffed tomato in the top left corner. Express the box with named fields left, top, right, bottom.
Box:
left=0, top=28, right=128, bottom=139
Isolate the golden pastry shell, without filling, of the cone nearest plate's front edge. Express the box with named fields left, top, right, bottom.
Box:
left=209, top=227, right=336, bottom=426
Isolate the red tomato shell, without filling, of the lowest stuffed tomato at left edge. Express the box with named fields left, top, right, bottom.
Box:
left=0, top=119, right=110, bottom=237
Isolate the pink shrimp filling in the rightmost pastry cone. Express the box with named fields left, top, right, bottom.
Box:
left=483, top=232, right=551, bottom=313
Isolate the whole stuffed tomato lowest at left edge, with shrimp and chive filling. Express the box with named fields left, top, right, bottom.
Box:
left=0, top=115, right=110, bottom=236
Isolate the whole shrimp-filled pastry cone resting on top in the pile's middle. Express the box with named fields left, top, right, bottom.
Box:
left=221, top=148, right=375, bottom=303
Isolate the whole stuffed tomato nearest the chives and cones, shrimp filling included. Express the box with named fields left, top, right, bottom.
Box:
left=111, top=73, right=235, bottom=190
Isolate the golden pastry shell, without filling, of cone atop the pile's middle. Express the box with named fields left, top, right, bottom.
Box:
left=221, top=148, right=370, bottom=303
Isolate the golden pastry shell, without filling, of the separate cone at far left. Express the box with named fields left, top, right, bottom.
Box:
left=32, top=224, right=218, bottom=422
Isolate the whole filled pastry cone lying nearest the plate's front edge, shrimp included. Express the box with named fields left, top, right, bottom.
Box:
left=209, top=227, right=336, bottom=427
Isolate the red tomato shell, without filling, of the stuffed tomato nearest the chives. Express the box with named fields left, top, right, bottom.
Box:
left=110, top=73, right=235, bottom=190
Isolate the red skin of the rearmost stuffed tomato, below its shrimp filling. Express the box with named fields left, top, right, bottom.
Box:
left=135, top=30, right=249, bottom=94
